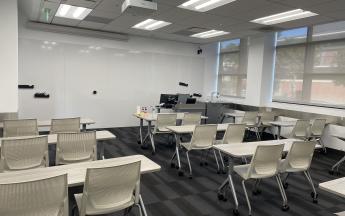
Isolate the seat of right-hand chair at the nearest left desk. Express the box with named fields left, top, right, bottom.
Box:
left=74, top=193, right=135, bottom=215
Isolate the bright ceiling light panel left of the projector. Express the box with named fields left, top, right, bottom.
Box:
left=55, top=4, right=92, bottom=20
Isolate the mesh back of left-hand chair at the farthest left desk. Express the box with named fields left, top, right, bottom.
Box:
left=4, top=119, right=38, bottom=137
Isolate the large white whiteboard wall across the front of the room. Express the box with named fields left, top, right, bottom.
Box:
left=19, top=21, right=205, bottom=127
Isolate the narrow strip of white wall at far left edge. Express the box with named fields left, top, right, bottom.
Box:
left=0, top=0, right=18, bottom=113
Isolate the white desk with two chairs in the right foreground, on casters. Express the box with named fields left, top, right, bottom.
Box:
left=213, top=139, right=321, bottom=213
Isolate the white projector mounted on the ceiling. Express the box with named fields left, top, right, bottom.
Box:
left=122, top=0, right=157, bottom=16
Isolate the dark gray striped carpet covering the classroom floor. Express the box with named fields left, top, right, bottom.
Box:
left=84, top=127, right=345, bottom=216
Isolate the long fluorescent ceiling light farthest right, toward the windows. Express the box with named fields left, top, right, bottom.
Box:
left=250, top=9, right=318, bottom=25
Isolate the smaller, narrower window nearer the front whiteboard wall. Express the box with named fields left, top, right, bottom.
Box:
left=218, top=39, right=247, bottom=97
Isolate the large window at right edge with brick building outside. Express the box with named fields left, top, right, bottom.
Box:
left=273, top=22, right=345, bottom=107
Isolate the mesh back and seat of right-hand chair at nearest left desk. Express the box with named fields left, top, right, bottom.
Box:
left=76, top=161, right=140, bottom=216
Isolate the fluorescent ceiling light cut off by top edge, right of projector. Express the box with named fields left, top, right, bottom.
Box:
left=178, top=0, right=236, bottom=12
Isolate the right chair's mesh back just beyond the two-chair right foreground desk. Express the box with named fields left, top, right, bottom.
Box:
left=222, top=124, right=246, bottom=144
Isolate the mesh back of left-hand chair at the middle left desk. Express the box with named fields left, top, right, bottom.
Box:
left=1, top=136, right=49, bottom=171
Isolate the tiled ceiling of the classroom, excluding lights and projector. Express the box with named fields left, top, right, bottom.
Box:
left=19, top=0, right=345, bottom=43
